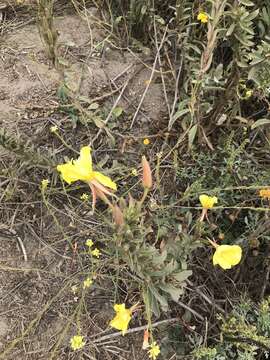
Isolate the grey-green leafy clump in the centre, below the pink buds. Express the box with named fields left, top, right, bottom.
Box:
left=109, top=195, right=199, bottom=316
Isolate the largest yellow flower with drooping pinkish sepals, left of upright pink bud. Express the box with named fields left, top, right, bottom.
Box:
left=57, top=146, right=116, bottom=210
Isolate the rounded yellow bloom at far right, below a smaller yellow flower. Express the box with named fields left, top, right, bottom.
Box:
left=213, top=245, right=242, bottom=270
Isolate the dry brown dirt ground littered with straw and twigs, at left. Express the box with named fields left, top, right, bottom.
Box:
left=0, top=6, right=169, bottom=360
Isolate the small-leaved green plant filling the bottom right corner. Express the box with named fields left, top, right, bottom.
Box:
left=193, top=298, right=270, bottom=360
